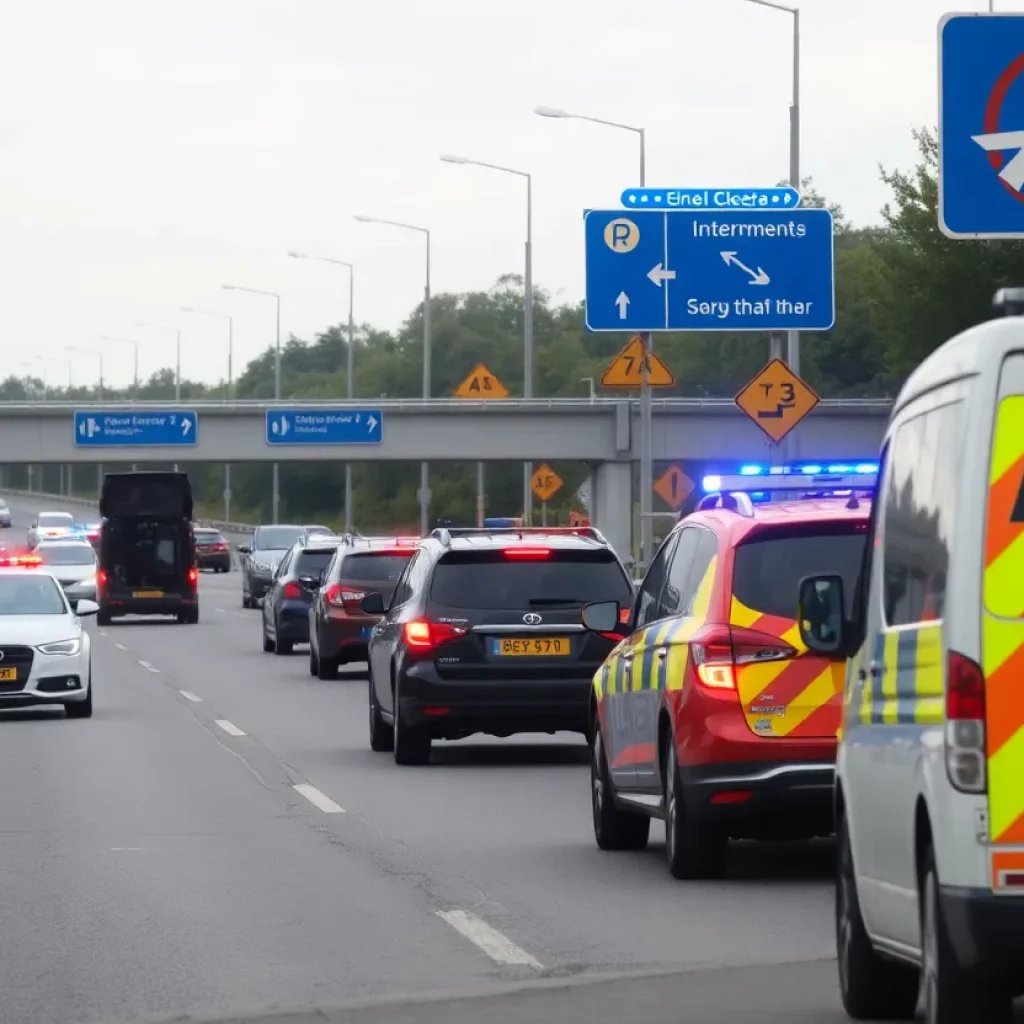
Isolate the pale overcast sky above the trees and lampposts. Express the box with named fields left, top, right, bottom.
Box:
left=0, top=0, right=1007, bottom=384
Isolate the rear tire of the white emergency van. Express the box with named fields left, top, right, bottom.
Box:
left=919, top=847, right=1013, bottom=1024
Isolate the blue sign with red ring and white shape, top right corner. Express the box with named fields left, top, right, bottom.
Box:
left=939, top=14, right=1024, bottom=239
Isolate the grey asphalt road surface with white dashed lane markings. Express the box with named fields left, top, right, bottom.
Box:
left=0, top=491, right=942, bottom=1024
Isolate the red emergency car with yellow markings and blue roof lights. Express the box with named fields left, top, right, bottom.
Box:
left=584, top=463, right=877, bottom=879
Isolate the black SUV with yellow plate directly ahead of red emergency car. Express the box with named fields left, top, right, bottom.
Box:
left=361, top=527, right=633, bottom=764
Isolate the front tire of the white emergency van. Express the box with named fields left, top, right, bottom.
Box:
left=836, top=815, right=921, bottom=1021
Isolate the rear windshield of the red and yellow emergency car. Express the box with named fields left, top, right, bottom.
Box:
left=732, top=524, right=867, bottom=618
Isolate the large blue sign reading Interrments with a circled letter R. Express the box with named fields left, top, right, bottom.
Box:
left=584, top=209, right=836, bottom=331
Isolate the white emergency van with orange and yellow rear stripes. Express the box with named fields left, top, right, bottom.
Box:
left=800, top=289, right=1024, bottom=1024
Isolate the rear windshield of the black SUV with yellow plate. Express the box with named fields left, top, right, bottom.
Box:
left=430, top=551, right=633, bottom=608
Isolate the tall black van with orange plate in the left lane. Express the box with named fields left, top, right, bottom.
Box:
left=96, top=472, right=199, bottom=626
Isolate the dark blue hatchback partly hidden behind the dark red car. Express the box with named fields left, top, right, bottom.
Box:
left=263, top=537, right=341, bottom=654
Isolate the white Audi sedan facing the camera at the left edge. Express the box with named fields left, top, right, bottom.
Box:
left=0, top=567, right=98, bottom=718
